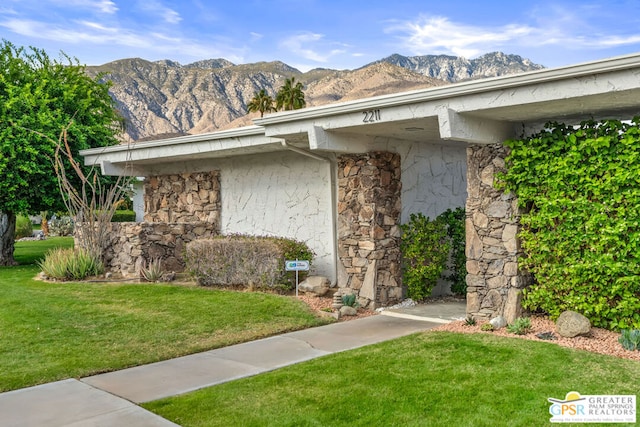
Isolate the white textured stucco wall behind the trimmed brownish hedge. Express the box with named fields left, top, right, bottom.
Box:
left=216, top=152, right=336, bottom=281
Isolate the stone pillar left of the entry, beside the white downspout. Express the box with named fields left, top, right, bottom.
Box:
left=337, top=152, right=403, bottom=308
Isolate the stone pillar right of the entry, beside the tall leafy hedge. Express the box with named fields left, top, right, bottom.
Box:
left=466, top=144, right=530, bottom=323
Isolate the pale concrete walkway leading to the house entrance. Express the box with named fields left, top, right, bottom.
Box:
left=0, top=303, right=465, bottom=427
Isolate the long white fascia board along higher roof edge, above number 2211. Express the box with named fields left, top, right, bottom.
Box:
left=254, top=54, right=640, bottom=126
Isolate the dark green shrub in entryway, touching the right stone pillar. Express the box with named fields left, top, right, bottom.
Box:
left=436, top=208, right=467, bottom=295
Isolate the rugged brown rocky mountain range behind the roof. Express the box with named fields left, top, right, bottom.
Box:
left=87, top=53, right=542, bottom=141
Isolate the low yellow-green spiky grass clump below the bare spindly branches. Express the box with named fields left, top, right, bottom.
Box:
left=38, top=248, right=104, bottom=280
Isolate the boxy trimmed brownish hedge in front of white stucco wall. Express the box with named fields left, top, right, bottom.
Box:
left=185, top=235, right=313, bottom=288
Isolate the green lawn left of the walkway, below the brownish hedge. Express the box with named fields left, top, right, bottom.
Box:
left=0, top=238, right=328, bottom=391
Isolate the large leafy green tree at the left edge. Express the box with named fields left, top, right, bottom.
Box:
left=0, top=40, right=123, bottom=265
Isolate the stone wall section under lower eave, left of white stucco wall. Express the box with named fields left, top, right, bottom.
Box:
left=144, top=171, right=220, bottom=229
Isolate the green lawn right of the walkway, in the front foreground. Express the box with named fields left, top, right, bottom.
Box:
left=143, top=332, right=640, bottom=427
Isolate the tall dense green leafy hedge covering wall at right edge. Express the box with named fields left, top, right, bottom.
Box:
left=500, top=118, right=640, bottom=329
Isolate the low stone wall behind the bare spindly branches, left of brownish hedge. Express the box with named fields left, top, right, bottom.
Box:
left=104, top=222, right=218, bottom=277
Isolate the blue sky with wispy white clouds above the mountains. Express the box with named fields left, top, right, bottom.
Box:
left=0, top=0, right=640, bottom=71
